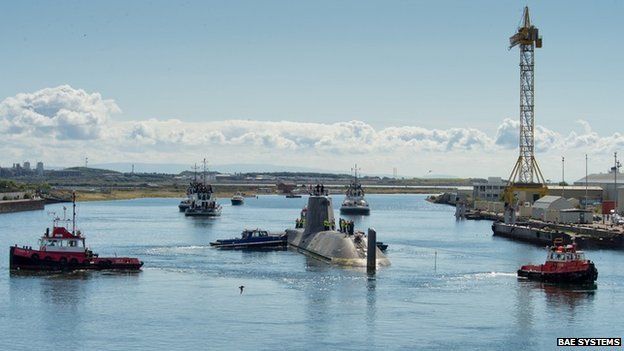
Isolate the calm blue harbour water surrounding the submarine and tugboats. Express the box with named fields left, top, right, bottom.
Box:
left=0, top=195, right=624, bottom=350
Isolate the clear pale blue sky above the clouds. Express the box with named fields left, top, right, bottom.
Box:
left=0, top=1, right=624, bottom=180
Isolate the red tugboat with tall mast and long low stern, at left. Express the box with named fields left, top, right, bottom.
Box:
left=9, top=195, right=143, bottom=271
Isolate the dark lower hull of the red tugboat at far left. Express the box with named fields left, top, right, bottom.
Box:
left=9, top=246, right=143, bottom=271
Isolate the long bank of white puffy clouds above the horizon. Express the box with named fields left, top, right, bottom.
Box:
left=0, top=85, right=624, bottom=176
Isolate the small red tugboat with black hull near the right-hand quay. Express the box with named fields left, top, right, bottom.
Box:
left=518, top=243, right=598, bottom=284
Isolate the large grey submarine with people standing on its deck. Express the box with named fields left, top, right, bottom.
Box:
left=286, top=185, right=390, bottom=267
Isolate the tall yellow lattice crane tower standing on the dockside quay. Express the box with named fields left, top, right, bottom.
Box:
left=505, top=7, right=547, bottom=203
